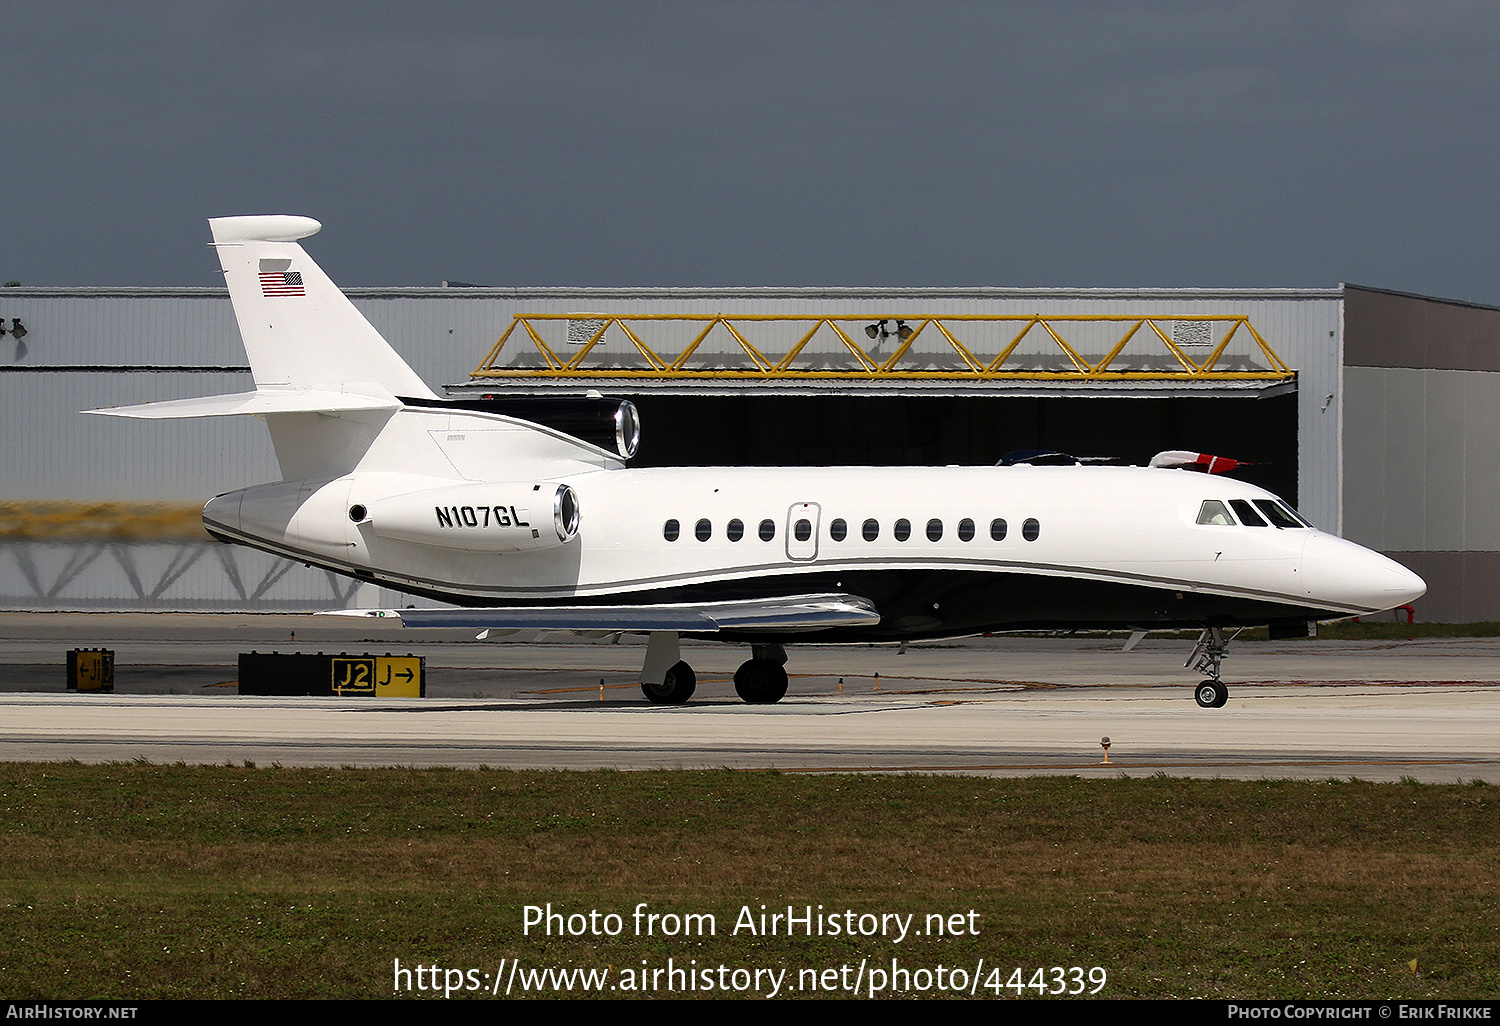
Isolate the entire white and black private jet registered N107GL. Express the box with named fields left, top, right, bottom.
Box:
left=92, top=216, right=1425, bottom=707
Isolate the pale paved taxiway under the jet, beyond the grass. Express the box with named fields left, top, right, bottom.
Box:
left=0, top=614, right=1500, bottom=783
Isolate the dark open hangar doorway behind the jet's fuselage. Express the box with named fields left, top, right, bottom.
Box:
left=615, top=392, right=1298, bottom=504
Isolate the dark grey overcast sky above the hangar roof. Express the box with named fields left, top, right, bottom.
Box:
left=0, top=0, right=1500, bottom=303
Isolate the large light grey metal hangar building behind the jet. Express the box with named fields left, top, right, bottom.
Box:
left=0, top=276, right=1500, bottom=621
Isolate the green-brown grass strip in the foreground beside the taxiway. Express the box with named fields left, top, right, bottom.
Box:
left=0, top=764, right=1500, bottom=999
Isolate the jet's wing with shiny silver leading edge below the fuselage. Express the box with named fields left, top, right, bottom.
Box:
left=330, top=594, right=881, bottom=633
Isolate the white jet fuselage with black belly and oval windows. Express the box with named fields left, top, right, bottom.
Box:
left=204, top=447, right=1419, bottom=641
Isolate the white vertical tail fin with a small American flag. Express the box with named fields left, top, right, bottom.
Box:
left=209, top=215, right=437, bottom=399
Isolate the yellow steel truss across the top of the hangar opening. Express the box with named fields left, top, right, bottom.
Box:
left=473, top=314, right=1296, bottom=383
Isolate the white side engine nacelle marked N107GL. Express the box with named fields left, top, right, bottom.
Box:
left=350, top=482, right=579, bottom=552
